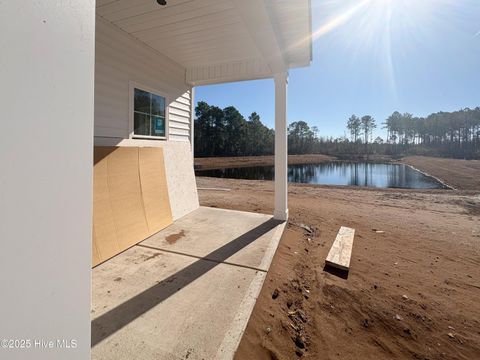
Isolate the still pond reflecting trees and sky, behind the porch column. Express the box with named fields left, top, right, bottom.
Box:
left=195, top=162, right=446, bottom=189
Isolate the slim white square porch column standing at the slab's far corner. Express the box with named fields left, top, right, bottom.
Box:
left=274, top=72, right=288, bottom=220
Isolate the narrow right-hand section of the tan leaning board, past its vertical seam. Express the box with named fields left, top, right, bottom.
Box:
left=139, top=148, right=173, bottom=234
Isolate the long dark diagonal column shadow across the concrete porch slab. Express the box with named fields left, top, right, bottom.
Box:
left=91, top=218, right=283, bottom=347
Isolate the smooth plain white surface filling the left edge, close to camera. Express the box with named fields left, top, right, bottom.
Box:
left=0, top=0, right=95, bottom=360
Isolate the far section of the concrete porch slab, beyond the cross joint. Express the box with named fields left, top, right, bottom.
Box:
left=142, top=207, right=283, bottom=271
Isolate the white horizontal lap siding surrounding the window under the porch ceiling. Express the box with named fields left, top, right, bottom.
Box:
left=95, top=17, right=191, bottom=142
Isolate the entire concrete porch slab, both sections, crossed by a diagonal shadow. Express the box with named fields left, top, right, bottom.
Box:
left=92, top=208, right=285, bottom=359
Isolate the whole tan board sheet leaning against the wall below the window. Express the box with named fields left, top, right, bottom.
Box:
left=92, top=147, right=172, bottom=265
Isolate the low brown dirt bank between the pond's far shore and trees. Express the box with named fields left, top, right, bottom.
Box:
left=191, top=154, right=335, bottom=170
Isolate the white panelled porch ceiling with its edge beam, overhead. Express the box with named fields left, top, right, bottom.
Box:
left=97, top=0, right=311, bottom=85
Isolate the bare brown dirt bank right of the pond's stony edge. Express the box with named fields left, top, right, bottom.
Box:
left=401, top=156, right=480, bottom=190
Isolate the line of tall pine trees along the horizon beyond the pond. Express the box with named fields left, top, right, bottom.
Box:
left=194, top=102, right=480, bottom=158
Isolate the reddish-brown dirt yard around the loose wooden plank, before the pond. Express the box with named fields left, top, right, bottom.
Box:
left=197, top=156, right=480, bottom=360
